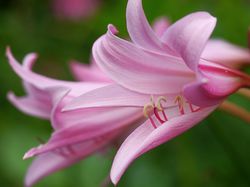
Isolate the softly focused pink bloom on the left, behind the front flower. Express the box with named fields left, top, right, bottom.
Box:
left=7, top=49, right=141, bottom=187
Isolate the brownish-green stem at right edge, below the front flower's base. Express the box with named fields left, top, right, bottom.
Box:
left=219, top=101, right=250, bottom=123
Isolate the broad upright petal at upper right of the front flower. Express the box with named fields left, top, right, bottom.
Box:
left=162, top=12, right=216, bottom=72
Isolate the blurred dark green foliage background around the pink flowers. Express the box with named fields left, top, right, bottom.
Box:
left=0, top=0, right=250, bottom=187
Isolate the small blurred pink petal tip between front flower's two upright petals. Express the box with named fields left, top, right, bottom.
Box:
left=153, top=17, right=170, bottom=37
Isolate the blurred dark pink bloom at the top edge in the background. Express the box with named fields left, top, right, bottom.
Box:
left=53, top=0, right=100, bottom=20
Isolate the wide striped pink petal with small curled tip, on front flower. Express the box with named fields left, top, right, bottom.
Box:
left=93, top=25, right=195, bottom=94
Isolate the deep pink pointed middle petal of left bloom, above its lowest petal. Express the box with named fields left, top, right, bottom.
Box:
left=25, top=107, right=143, bottom=158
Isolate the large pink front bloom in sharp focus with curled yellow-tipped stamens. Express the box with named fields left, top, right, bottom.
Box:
left=64, top=0, right=250, bottom=184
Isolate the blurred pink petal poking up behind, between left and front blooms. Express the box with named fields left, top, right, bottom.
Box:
left=70, top=61, right=111, bottom=82
